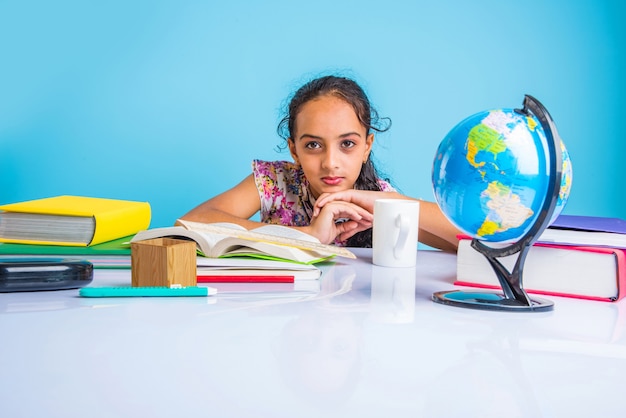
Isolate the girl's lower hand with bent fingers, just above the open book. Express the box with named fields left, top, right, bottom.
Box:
left=307, top=200, right=374, bottom=244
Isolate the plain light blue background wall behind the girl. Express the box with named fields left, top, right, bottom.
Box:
left=0, top=0, right=626, bottom=227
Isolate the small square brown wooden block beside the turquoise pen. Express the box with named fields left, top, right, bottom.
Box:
left=130, top=238, right=198, bottom=287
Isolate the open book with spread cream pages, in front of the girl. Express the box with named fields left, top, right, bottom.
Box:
left=131, top=219, right=356, bottom=264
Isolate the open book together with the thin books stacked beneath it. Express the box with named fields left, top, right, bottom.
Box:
left=132, top=219, right=355, bottom=287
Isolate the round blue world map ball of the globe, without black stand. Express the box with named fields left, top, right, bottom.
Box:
left=432, top=109, right=572, bottom=243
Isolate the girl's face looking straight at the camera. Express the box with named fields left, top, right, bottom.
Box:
left=288, top=96, right=374, bottom=198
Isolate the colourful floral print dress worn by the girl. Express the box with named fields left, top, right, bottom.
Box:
left=252, top=160, right=394, bottom=245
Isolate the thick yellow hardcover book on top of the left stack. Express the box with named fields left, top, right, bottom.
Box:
left=0, top=196, right=151, bottom=246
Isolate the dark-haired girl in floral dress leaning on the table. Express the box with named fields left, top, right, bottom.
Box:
left=183, top=76, right=458, bottom=251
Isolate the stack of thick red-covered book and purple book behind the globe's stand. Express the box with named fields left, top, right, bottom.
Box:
left=455, top=215, right=626, bottom=301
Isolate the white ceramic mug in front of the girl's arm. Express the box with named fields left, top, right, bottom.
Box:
left=372, top=199, right=420, bottom=267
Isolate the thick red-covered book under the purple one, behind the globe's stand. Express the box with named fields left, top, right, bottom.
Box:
left=454, top=237, right=626, bottom=302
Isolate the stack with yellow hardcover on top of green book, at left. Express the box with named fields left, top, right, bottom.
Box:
left=0, top=195, right=151, bottom=268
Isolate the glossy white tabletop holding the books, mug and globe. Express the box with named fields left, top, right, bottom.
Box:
left=0, top=249, right=626, bottom=418
